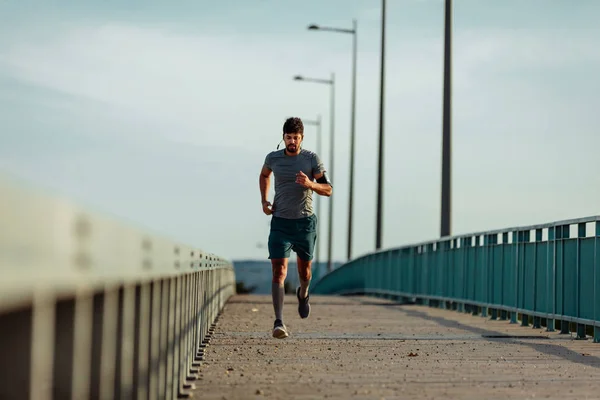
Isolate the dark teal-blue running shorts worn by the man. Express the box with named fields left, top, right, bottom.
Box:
left=269, top=214, right=317, bottom=261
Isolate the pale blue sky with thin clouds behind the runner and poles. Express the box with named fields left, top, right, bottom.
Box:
left=0, top=0, right=600, bottom=261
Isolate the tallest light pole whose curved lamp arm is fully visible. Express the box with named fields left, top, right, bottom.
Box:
left=308, top=19, right=357, bottom=260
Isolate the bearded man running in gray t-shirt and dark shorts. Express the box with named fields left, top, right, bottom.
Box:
left=259, top=118, right=332, bottom=339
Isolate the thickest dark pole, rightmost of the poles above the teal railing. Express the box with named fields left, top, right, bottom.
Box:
left=440, top=0, right=452, bottom=237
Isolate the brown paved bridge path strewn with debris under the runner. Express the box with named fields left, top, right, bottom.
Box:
left=194, top=295, right=600, bottom=400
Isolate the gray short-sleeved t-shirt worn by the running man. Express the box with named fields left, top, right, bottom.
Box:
left=264, top=149, right=325, bottom=219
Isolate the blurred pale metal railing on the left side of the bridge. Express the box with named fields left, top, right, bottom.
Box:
left=0, top=181, right=235, bottom=400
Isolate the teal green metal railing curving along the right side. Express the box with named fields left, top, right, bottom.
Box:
left=312, top=216, right=600, bottom=342
